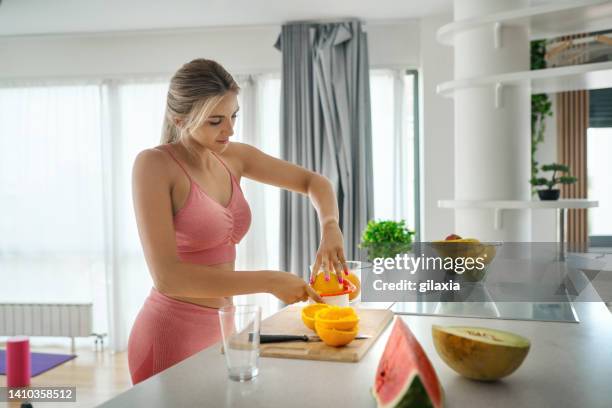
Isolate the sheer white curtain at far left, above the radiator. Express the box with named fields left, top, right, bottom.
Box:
left=0, top=81, right=108, bottom=332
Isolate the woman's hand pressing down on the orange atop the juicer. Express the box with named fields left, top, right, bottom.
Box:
left=310, top=220, right=348, bottom=284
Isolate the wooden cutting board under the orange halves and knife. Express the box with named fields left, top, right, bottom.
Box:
left=259, top=304, right=393, bottom=362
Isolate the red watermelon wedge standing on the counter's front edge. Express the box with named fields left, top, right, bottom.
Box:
left=372, top=318, right=443, bottom=408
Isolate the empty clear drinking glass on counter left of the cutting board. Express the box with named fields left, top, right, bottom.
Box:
left=219, top=305, right=261, bottom=382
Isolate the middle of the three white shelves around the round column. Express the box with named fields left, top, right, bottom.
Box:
left=437, top=61, right=612, bottom=97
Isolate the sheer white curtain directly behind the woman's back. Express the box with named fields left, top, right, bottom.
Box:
left=102, top=78, right=168, bottom=350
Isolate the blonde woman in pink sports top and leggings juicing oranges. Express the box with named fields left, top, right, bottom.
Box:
left=128, top=59, right=348, bottom=384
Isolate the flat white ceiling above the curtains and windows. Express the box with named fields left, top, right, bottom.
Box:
left=0, top=0, right=452, bottom=35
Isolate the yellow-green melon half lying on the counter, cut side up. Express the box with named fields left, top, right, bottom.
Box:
left=431, top=325, right=530, bottom=381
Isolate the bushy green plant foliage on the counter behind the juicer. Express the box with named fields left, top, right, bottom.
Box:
left=360, top=220, right=414, bottom=261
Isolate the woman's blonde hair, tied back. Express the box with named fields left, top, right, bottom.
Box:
left=160, top=58, right=240, bottom=144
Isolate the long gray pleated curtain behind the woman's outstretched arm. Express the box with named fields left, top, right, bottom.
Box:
left=276, top=20, right=374, bottom=277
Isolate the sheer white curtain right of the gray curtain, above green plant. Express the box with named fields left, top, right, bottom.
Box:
left=370, top=69, right=415, bottom=229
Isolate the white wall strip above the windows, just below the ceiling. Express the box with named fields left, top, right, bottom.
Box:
left=0, top=20, right=419, bottom=79
